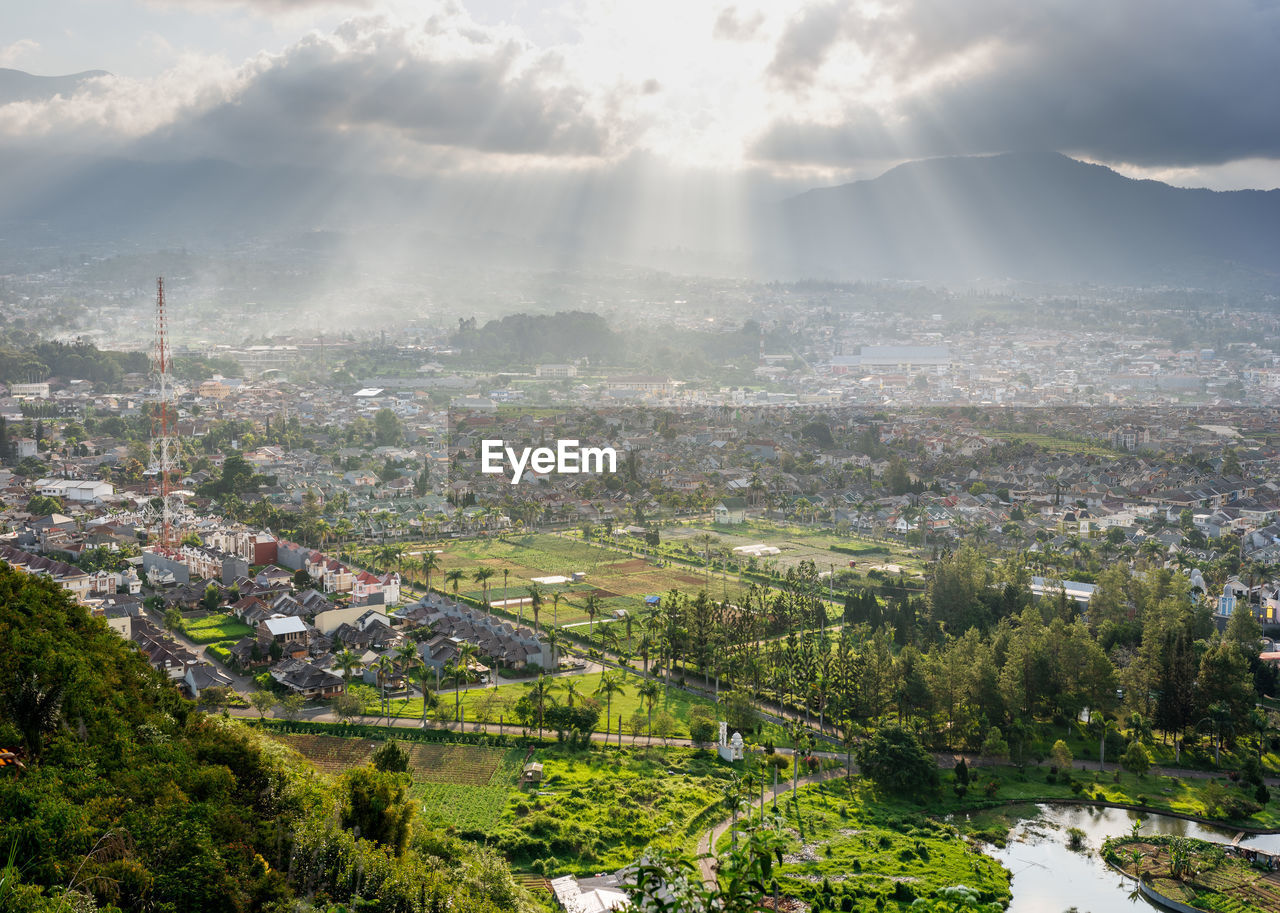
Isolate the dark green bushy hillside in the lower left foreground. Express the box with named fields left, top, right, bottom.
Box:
left=0, top=566, right=530, bottom=913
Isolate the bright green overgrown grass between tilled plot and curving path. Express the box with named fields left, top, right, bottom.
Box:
left=497, top=747, right=735, bottom=876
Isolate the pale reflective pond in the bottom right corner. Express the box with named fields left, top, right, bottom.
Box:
left=987, top=805, right=1280, bottom=913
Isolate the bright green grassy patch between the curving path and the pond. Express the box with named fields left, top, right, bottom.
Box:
left=717, top=777, right=1010, bottom=910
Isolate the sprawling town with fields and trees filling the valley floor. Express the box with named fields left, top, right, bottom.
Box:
left=0, top=277, right=1280, bottom=909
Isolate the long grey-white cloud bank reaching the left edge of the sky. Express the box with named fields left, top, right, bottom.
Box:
left=0, top=9, right=612, bottom=170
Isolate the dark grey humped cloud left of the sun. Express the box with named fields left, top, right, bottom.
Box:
left=147, top=23, right=608, bottom=165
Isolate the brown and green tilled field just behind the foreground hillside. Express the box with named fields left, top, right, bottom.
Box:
left=268, top=732, right=526, bottom=834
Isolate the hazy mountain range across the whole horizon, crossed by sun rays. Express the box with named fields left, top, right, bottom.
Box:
left=0, top=133, right=1280, bottom=286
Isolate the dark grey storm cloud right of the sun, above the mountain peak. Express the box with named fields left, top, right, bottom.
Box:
left=751, top=0, right=1280, bottom=165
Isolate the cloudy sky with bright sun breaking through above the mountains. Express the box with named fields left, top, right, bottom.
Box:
left=0, top=0, right=1280, bottom=190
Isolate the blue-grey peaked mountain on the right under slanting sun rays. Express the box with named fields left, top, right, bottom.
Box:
left=762, top=152, right=1280, bottom=286
